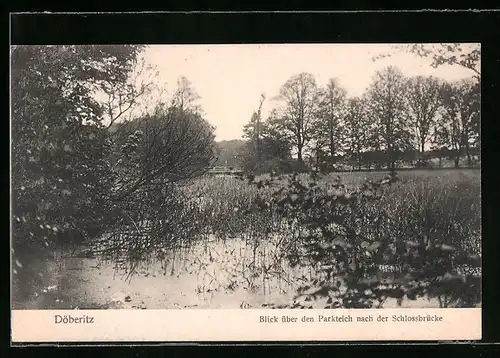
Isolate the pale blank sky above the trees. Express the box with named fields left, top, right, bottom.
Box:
left=139, top=44, right=478, bottom=140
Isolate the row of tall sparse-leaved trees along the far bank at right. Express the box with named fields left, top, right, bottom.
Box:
left=244, top=44, right=481, bottom=171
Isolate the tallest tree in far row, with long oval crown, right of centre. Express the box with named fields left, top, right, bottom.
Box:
left=368, top=66, right=411, bottom=169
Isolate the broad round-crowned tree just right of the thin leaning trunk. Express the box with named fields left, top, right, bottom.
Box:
left=273, top=73, right=319, bottom=162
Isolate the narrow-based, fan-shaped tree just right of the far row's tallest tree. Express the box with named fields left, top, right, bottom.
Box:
left=406, top=76, right=442, bottom=165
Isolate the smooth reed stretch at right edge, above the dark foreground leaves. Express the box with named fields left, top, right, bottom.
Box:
left=374, top=174, right=481, bottom=254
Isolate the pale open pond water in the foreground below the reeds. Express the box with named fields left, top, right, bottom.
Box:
left=13, top=239, right=439, bottom=309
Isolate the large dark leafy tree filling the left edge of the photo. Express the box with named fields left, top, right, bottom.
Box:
left=11, top=45, right=142, bottom=300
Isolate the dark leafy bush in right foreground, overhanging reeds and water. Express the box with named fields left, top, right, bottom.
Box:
left=246, top=174, right=480, bottom=308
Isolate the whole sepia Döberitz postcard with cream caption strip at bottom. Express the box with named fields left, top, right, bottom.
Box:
left=10, top=43, right=482, bottom=343
